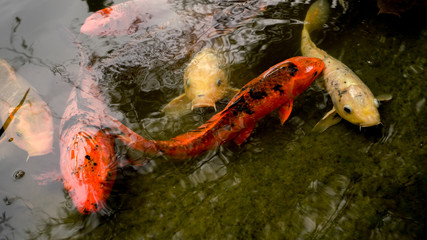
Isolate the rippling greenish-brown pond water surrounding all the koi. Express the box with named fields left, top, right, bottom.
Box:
left=0, top=0, right=427, bottom=239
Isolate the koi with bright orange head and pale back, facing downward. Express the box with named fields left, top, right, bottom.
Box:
left=60, top=48, right=145, bottom=214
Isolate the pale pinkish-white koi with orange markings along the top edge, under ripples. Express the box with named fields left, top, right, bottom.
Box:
left=80, top=0, right=266, bottom=36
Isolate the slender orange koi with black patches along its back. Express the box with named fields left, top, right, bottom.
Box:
left=118, top=57, right=324, bottom=159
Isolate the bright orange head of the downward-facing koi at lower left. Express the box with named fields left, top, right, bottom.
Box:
left=61, top=127, right=117, bottom=214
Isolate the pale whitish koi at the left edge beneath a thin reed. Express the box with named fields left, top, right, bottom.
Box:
left=0, top=59, right=53, bottom=157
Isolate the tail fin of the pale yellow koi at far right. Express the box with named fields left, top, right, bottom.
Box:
left=304, top=0, right=330, bottom=33
